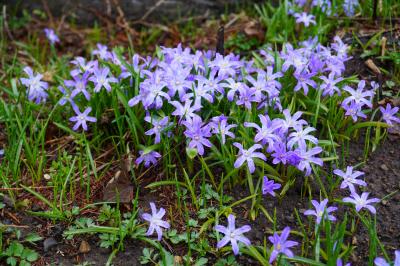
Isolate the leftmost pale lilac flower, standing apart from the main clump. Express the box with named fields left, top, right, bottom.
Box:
left=20, top=66, right=49, bottom=104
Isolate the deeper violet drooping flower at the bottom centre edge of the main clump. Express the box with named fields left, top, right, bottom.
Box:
left=182, top=115, right=212, bottom=155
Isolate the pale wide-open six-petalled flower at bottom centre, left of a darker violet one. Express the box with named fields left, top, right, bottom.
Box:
left=214, top=214, right=251, bottom=255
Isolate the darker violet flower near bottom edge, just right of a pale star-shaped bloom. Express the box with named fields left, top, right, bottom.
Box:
left=268, top=226, right=299, bottom=263
